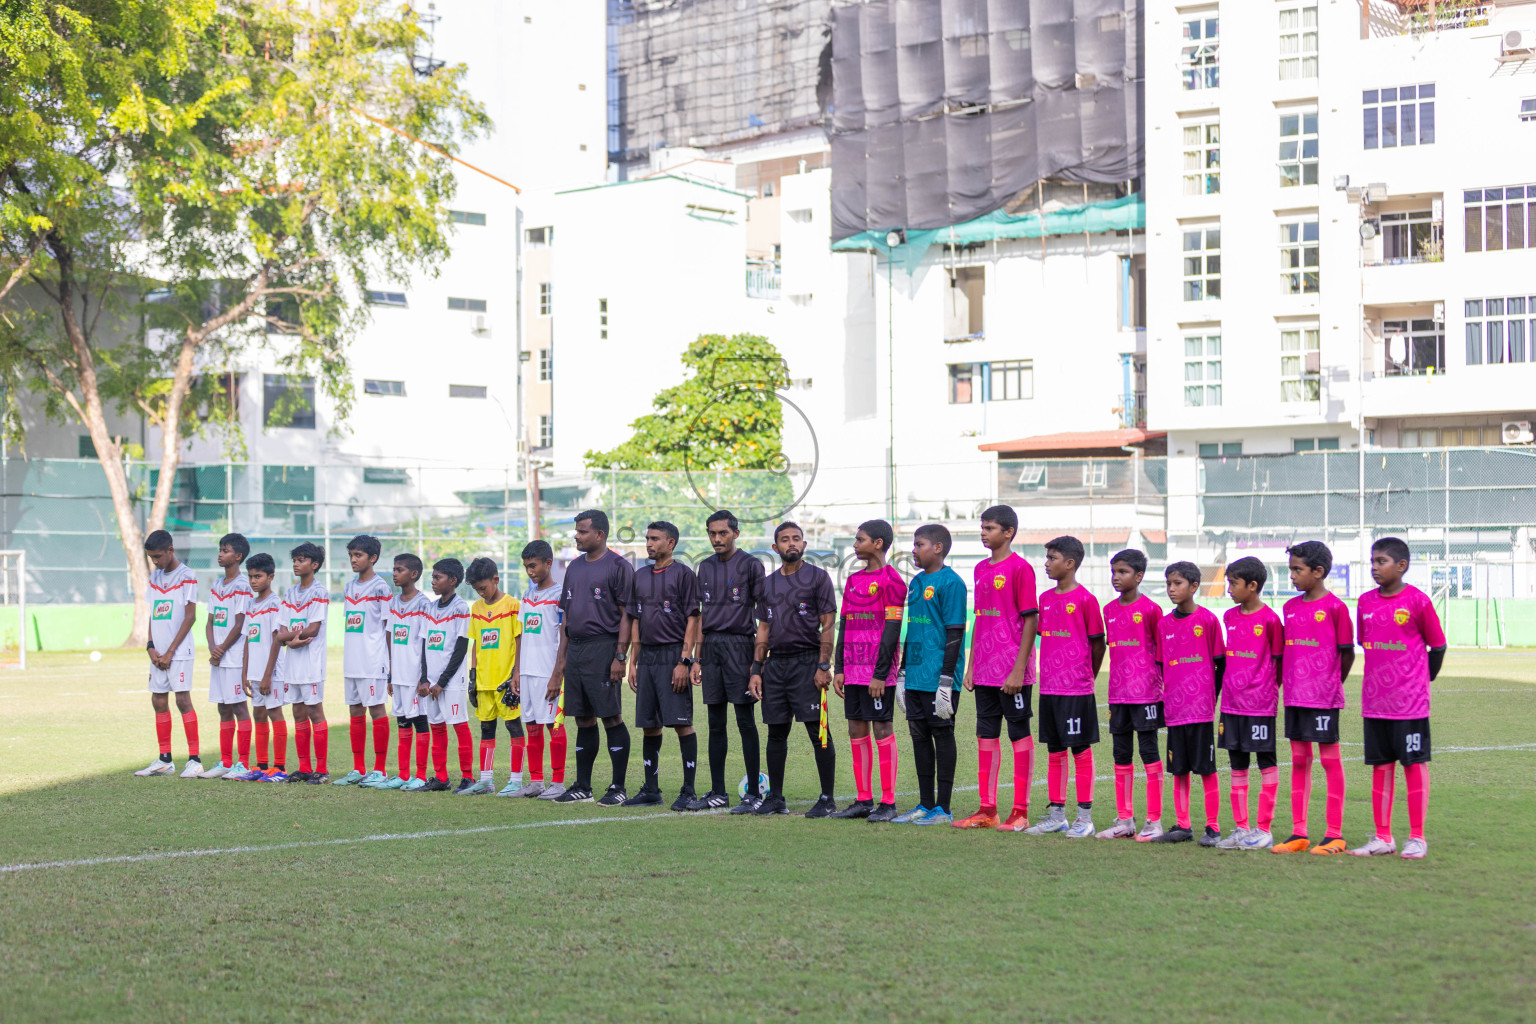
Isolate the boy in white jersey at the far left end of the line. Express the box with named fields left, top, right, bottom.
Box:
left=134, top=530, right=203, bottom=778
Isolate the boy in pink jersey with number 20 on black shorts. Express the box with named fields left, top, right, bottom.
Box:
left=1217, top=556, right=1286, bottom=851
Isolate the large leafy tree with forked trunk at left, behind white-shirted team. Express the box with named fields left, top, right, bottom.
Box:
left=0, top=0, right=490, bottom=643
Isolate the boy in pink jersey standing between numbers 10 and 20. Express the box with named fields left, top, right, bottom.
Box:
left=1150, top=562, right=1227, bottom=846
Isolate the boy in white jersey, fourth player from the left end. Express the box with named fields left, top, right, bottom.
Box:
left=276, top=542, right=330, bottom=786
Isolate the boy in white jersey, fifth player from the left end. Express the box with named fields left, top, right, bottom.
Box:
left=332, top=533, right=395, bottom=786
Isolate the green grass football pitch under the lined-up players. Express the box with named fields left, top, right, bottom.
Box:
left=0, top=651, right=1536, bottom=1024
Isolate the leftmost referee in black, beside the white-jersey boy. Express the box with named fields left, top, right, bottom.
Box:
left=545, top=510, right=634, bottom=808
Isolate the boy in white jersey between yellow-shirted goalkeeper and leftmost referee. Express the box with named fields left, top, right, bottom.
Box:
left=518, top=540, right=565, bottom=800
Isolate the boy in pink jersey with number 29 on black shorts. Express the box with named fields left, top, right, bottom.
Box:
left=1350, top=537, right=1445, bottom=860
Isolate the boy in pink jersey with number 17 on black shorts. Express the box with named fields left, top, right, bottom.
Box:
left=1273, top=540, right=1355, bottom=855
